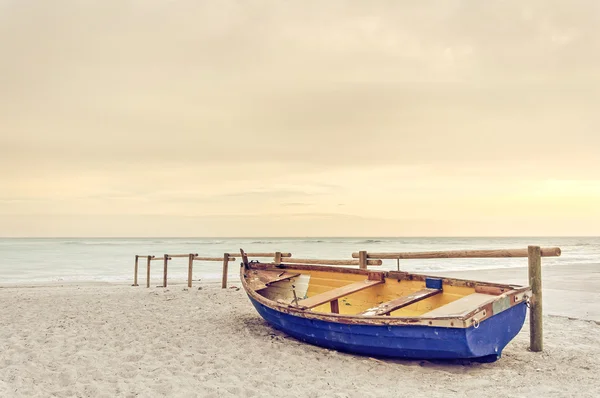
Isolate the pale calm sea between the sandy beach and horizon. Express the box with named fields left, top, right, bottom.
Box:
left=0, top=237, right=600, bottom=286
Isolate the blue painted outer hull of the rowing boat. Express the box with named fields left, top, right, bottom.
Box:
left=249, top=297, right=527, bottom=362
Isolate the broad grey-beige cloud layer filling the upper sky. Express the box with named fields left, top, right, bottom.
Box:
left=0, top=1, right=600, bottom=171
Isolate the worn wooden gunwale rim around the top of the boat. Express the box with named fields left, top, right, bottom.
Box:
left=240, top=261, right=531, bottom=329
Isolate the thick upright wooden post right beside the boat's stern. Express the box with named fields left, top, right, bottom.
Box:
left=527, top=246, right=544, bottom=352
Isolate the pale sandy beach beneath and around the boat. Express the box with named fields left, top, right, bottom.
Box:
left=0, top=266, right=600, bottom=397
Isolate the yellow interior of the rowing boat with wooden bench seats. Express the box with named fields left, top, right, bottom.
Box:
left=243, top=264, right=526, bottom=318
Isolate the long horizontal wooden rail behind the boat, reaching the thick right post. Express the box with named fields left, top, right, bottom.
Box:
left=352, top=247, right=561, bottom=260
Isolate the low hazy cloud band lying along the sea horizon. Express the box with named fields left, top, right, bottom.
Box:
left=0, top=213, right=600, bottom=237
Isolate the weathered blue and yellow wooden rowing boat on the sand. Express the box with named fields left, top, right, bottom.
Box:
left=240, top=250, right=531, bottom=362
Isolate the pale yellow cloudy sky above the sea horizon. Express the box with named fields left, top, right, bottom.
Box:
left=0, top=0, right=600, bottom=236
